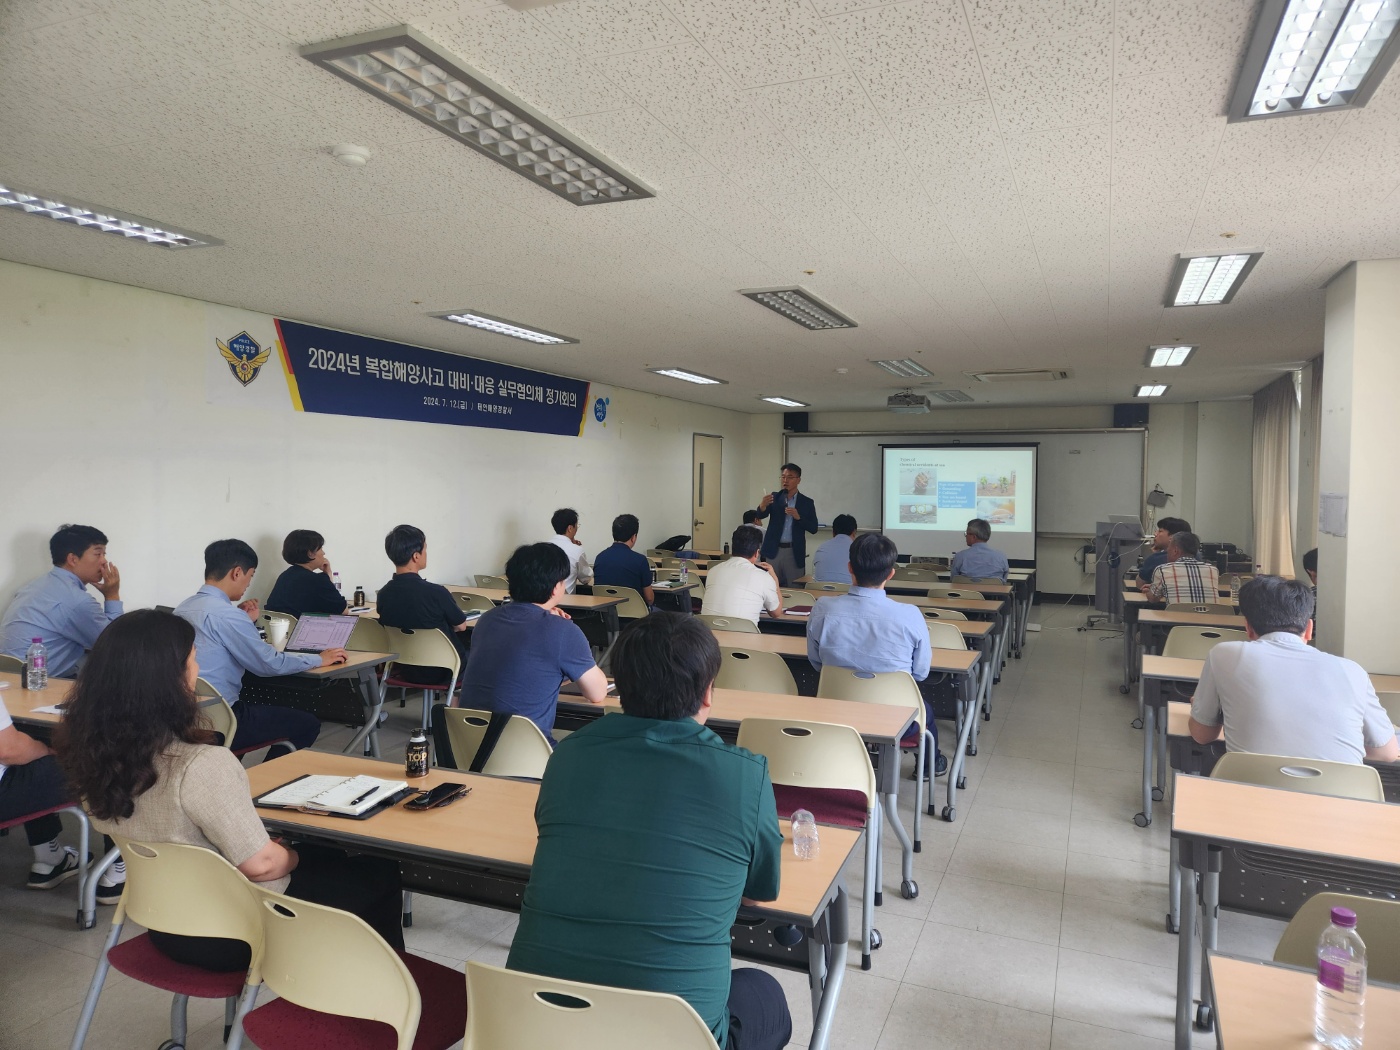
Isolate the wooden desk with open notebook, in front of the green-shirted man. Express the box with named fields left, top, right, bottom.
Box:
left=248, top=750, right=860, bottom=1050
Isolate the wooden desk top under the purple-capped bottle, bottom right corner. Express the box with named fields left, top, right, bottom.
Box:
left=1210, top=952, right=1400, bottom=1050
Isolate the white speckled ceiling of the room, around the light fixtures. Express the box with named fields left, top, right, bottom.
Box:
left=0, top=0, right=1400, bottom=419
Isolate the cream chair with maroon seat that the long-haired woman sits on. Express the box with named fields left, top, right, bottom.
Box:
left=73, top=836, right=265, bottom=1050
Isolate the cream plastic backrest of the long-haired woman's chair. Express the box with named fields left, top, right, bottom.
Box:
left=112, top=834, right=263, bottom=952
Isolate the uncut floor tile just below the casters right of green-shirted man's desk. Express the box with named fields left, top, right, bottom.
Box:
left=904, top=923, right=1057, bottom=1014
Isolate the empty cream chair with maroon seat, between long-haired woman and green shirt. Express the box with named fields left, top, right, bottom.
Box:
left=244, top=886, right=466, bottom=1050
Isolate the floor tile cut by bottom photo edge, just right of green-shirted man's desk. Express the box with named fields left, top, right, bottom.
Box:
left=876, top=984, right=1050, bottom=1050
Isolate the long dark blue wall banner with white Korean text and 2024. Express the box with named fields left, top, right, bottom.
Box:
left=276, top=318, right=588, bottom=437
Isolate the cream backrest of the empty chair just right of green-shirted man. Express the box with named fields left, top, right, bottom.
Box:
left=739, top=718, right=879, bottom=806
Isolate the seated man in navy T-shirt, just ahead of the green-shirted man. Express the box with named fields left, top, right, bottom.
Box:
left=461, top=543, right=608, bottom=736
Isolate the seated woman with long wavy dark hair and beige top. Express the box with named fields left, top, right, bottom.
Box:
left=55, top=609, right=403, bottom=972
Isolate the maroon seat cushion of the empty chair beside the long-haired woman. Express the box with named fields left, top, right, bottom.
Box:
left=244, top=952, right=466, bottom=1050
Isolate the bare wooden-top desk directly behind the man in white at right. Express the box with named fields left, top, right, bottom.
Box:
left=1172, top=777, right=1400, bottom=1050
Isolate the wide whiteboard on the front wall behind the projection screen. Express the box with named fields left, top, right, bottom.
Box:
left=787, top=428, right=1147, bottom=538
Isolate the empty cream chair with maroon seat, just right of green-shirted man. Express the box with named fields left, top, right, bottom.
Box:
left=739, top=718, right=881, bottom=970
